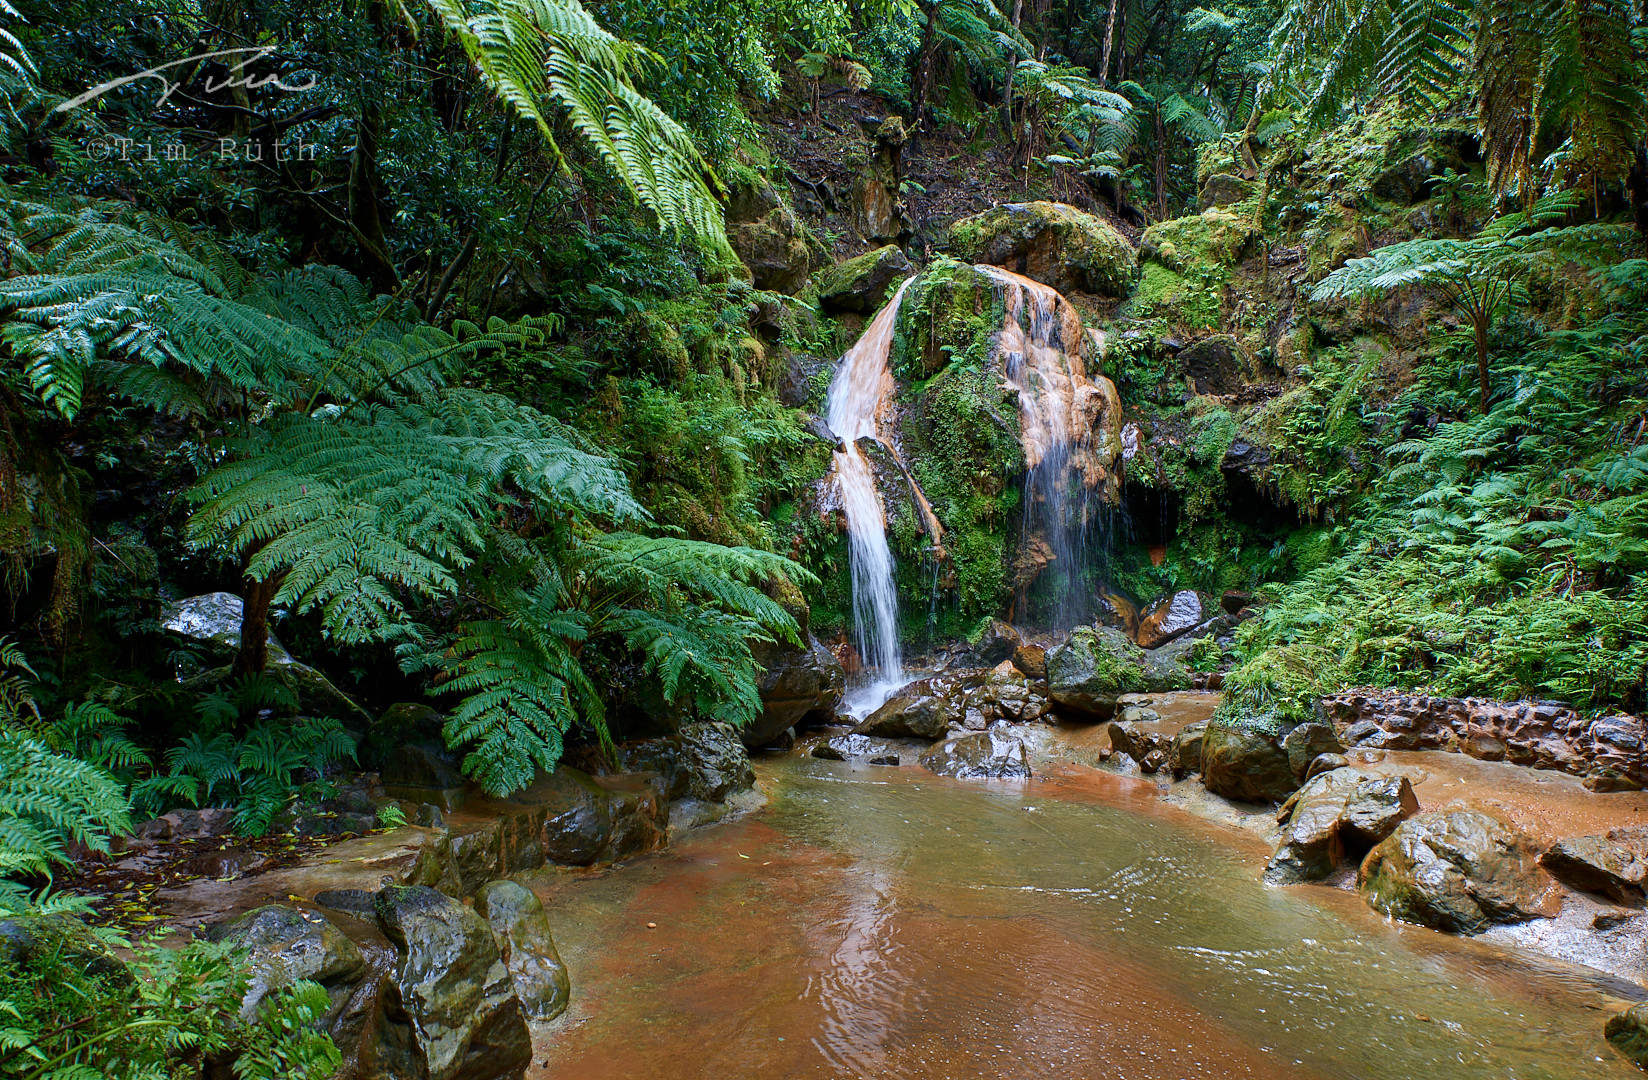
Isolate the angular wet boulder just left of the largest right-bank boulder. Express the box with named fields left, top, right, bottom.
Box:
left=1264, top=768, right=1419, bottom=885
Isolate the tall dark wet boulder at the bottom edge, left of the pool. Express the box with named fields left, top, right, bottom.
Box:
left=376, top=885, right=532, bottom=1080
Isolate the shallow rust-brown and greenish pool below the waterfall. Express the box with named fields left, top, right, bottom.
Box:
left=531, top=757, right=1636, bottom=1080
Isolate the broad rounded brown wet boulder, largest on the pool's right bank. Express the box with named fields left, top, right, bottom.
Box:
left=1358, top=803, right=1559, bottom=933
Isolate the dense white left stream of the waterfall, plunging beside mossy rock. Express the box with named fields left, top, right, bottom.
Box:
left=826, top=279, right=938, bottom=711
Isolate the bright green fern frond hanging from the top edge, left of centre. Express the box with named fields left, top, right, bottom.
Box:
left=430, top=0, right=730, bottom=257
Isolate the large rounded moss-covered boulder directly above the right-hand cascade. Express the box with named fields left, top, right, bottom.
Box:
left=946, top=203, right=1139, bottom=297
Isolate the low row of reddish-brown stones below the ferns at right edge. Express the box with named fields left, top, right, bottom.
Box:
left=1322, top=689, right=1648, bottom=791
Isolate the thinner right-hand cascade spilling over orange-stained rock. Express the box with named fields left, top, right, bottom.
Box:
left=977, top=265, right=1116, bottom=630
